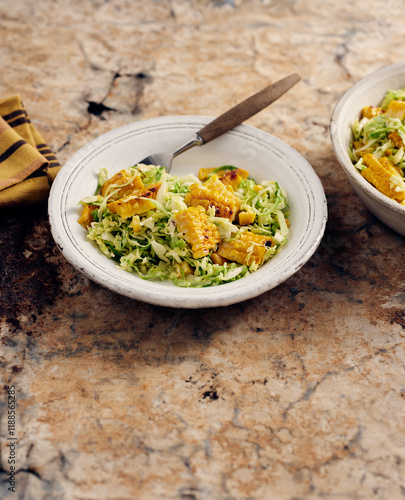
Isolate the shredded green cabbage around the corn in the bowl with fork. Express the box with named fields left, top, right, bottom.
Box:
left=79, top=165, right=289, bottom=287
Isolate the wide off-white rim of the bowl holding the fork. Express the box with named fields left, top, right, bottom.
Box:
left=48, top=115, right=327, bottom=309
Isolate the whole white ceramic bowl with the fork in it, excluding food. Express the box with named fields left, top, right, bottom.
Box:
left=49, top=116, right=327, bottom=308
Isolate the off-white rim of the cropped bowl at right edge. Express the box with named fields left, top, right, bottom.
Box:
left=330, top=61, right=405, bottom=216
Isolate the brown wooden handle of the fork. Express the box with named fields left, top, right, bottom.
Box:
left=197, top=73, right=301, bottom=144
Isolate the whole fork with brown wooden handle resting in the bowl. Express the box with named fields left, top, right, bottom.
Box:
left=138, top=73, right=301, bottom=172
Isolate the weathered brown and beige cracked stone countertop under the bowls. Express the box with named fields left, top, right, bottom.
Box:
left=0, top=0, right=405, bottom=500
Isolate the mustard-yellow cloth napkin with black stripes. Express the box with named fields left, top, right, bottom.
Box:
left=0, top=95, right=61, bottom=207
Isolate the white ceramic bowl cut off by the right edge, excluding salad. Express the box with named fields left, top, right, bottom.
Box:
left=330, top=62, right=405, bottom=235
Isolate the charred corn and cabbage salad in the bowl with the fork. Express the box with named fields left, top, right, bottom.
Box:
left=79, top=164, right=289, bottom=287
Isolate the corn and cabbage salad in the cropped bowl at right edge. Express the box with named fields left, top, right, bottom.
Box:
left=349, top=89, right=405, bottom=205
